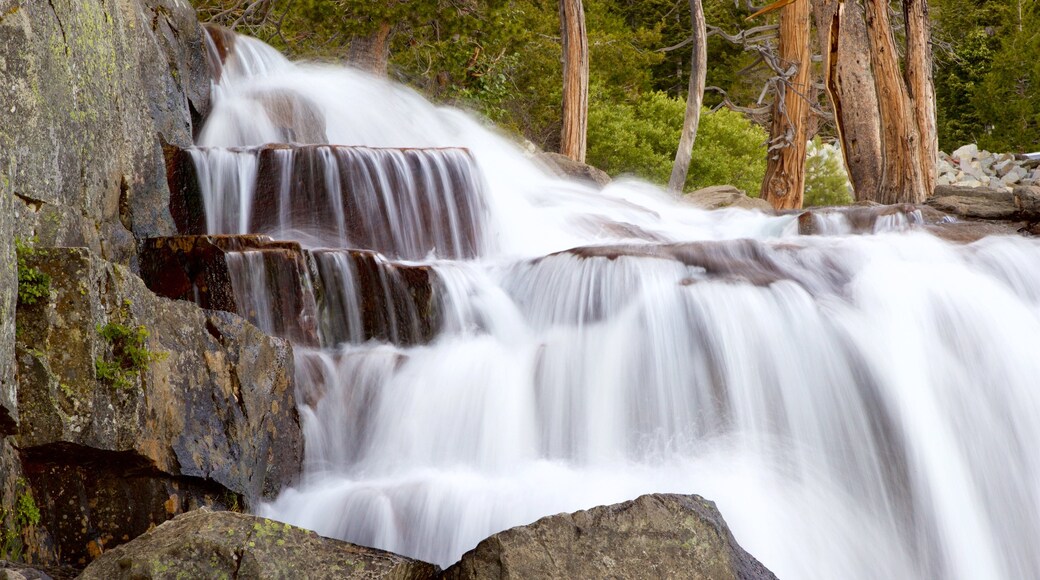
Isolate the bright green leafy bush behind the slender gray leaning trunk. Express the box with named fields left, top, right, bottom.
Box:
left=588, top=93, right=766, bottom=195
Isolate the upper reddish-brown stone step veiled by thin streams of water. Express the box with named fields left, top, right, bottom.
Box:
left=165, top=144, right=486, bottom=260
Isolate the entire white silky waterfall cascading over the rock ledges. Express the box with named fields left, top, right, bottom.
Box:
left=189, top=29, right=1040, bottom=579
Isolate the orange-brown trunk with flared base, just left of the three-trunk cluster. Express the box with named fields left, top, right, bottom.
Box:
left=761, top=0, right=812, bottom=209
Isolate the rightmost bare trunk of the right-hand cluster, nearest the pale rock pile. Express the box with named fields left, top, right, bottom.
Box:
left=903, top=0, right=939, bottom=196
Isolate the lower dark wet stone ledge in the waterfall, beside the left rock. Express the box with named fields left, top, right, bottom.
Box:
left=141, top=235, right=440, bottom=347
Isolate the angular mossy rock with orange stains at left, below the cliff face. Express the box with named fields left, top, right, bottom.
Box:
left=15, top=248, right=303, bottom=564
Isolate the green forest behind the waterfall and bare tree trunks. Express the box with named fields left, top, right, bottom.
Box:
left=192, top=0, right=1040, bottom=206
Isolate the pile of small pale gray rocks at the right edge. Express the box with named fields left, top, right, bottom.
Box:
left=937, top=143, right=1040, bottom=190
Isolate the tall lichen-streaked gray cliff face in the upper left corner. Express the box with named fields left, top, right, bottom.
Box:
left=0, top=0, right=209, bottom=261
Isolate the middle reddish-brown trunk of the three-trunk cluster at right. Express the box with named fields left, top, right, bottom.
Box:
left=865, top=0, right=928, bottom=204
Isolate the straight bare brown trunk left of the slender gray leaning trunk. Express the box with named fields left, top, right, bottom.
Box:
left=560, top=0, right=589, bottom=163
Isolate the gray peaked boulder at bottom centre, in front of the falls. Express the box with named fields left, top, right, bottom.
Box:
left=443, top=495, right=775, bottom=580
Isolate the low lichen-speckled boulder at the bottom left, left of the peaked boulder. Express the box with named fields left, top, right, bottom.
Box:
left=80, top=510, right=438, bottom=580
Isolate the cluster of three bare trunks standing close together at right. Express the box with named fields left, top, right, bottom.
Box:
left=814, top=0, right=938, bottom=204
